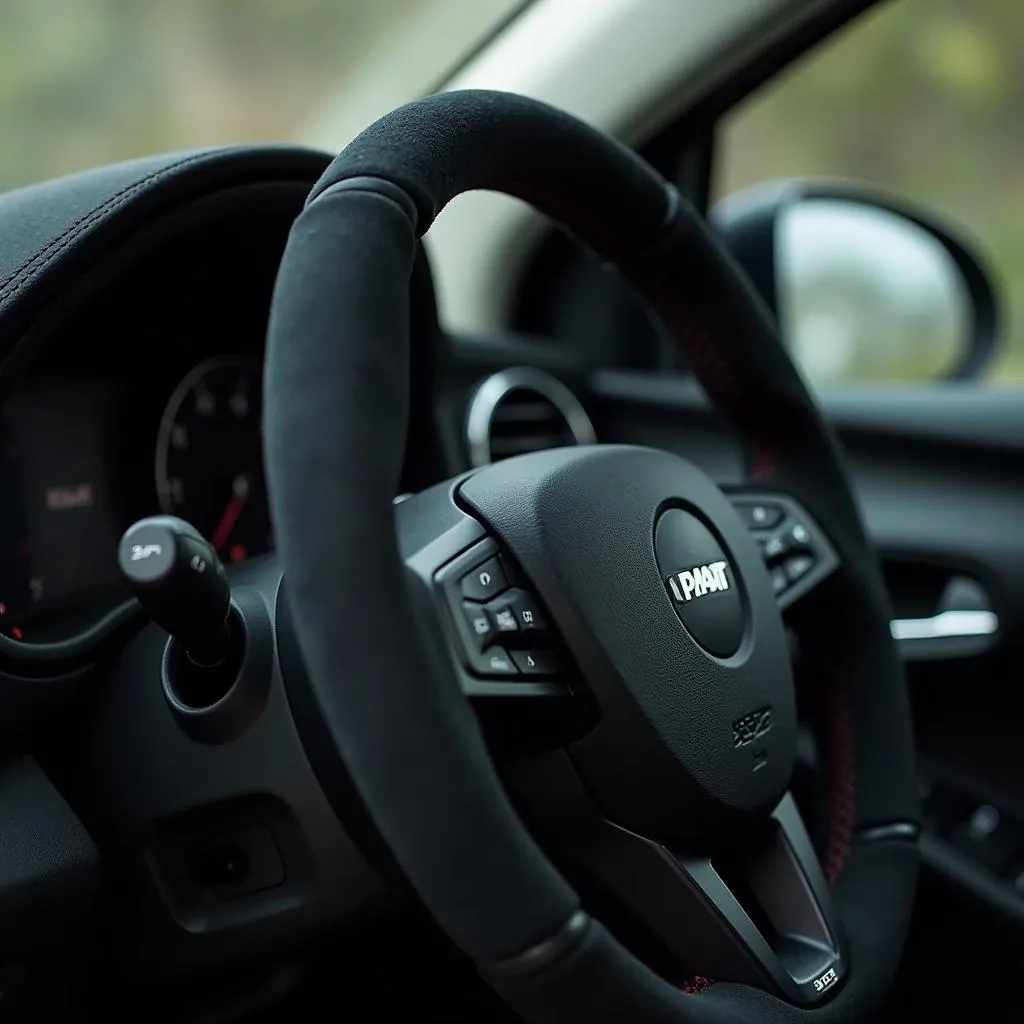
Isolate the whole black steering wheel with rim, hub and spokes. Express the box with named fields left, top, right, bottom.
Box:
left=265, top=91, right=918, bottom=1024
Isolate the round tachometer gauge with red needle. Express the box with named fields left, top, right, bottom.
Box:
left=157, top=356, right=273, bottom=562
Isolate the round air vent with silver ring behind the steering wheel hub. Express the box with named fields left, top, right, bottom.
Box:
left=466, top=367, right=596, bottom=466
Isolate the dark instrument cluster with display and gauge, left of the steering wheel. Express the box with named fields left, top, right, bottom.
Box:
left=0, top=351, right=273, bottom=643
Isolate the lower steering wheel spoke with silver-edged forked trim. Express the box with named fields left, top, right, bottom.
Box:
left=510, top=752, right=848, bottom=1006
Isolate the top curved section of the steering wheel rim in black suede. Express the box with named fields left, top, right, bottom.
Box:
left=310, top=90, right=669, bottom=260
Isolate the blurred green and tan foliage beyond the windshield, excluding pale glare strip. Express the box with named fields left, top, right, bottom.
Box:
left=0, top=0, right=422, bottom=188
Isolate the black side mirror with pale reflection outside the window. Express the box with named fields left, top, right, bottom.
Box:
left=712, top=181, right=1000, bottom=384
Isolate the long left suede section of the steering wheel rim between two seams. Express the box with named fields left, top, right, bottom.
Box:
left=264, top=191, right=578, bottom=959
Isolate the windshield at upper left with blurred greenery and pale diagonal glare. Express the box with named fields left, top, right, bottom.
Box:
left=0, top=0, right=521, bottom=189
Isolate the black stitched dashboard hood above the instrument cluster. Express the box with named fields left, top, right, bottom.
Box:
left=0, top=145, right=331, bottom=358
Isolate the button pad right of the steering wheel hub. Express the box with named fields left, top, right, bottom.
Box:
left=723, top=484, right=840, bottom=611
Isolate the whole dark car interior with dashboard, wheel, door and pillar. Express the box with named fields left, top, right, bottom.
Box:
left=0, top=0, right=1024, bottom=1024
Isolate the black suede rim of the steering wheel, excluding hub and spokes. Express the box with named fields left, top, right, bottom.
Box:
left=264, top=91, right=918, bottom=1024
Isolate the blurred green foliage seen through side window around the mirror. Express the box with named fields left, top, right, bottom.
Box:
left=717, top=0, right=1024, bottom=383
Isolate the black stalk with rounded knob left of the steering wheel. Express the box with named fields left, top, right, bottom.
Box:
left=118, top=515, right=231, bottom=668
